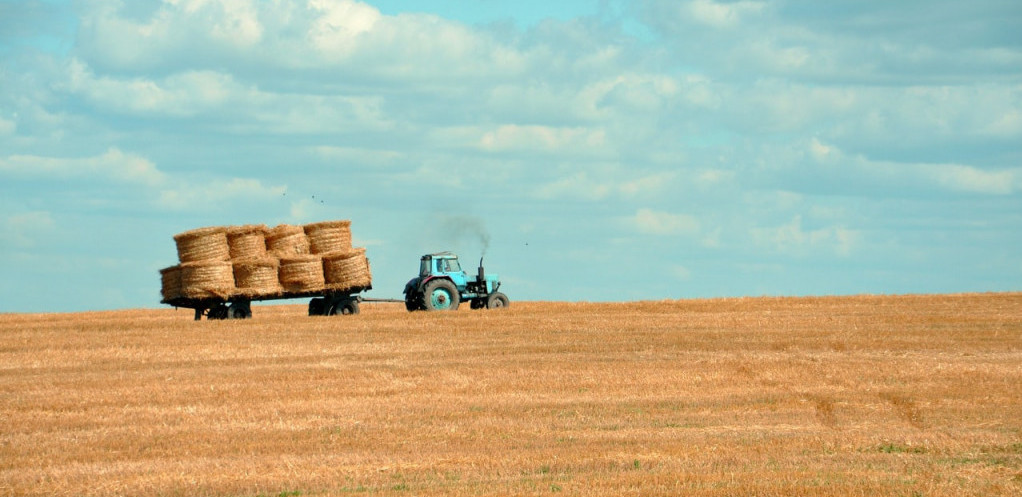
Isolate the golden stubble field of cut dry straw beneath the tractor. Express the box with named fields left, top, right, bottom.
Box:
left=0, top=293, right=1022, bottom=496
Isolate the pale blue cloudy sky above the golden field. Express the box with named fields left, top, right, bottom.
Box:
left=0, top=0, right=1022, bottom=312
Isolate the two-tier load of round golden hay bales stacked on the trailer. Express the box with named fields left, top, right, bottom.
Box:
left=159, top=220, right=372, bottom=303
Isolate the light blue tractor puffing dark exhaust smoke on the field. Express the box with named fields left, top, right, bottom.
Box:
left=405, top=252, right=510, bottom=311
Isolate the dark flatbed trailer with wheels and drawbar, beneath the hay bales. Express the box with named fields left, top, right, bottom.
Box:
left=160, top=286, right=405, bottom=321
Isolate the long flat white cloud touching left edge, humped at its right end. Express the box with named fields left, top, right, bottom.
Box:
left=0, top=147, right=166, bottom=186
